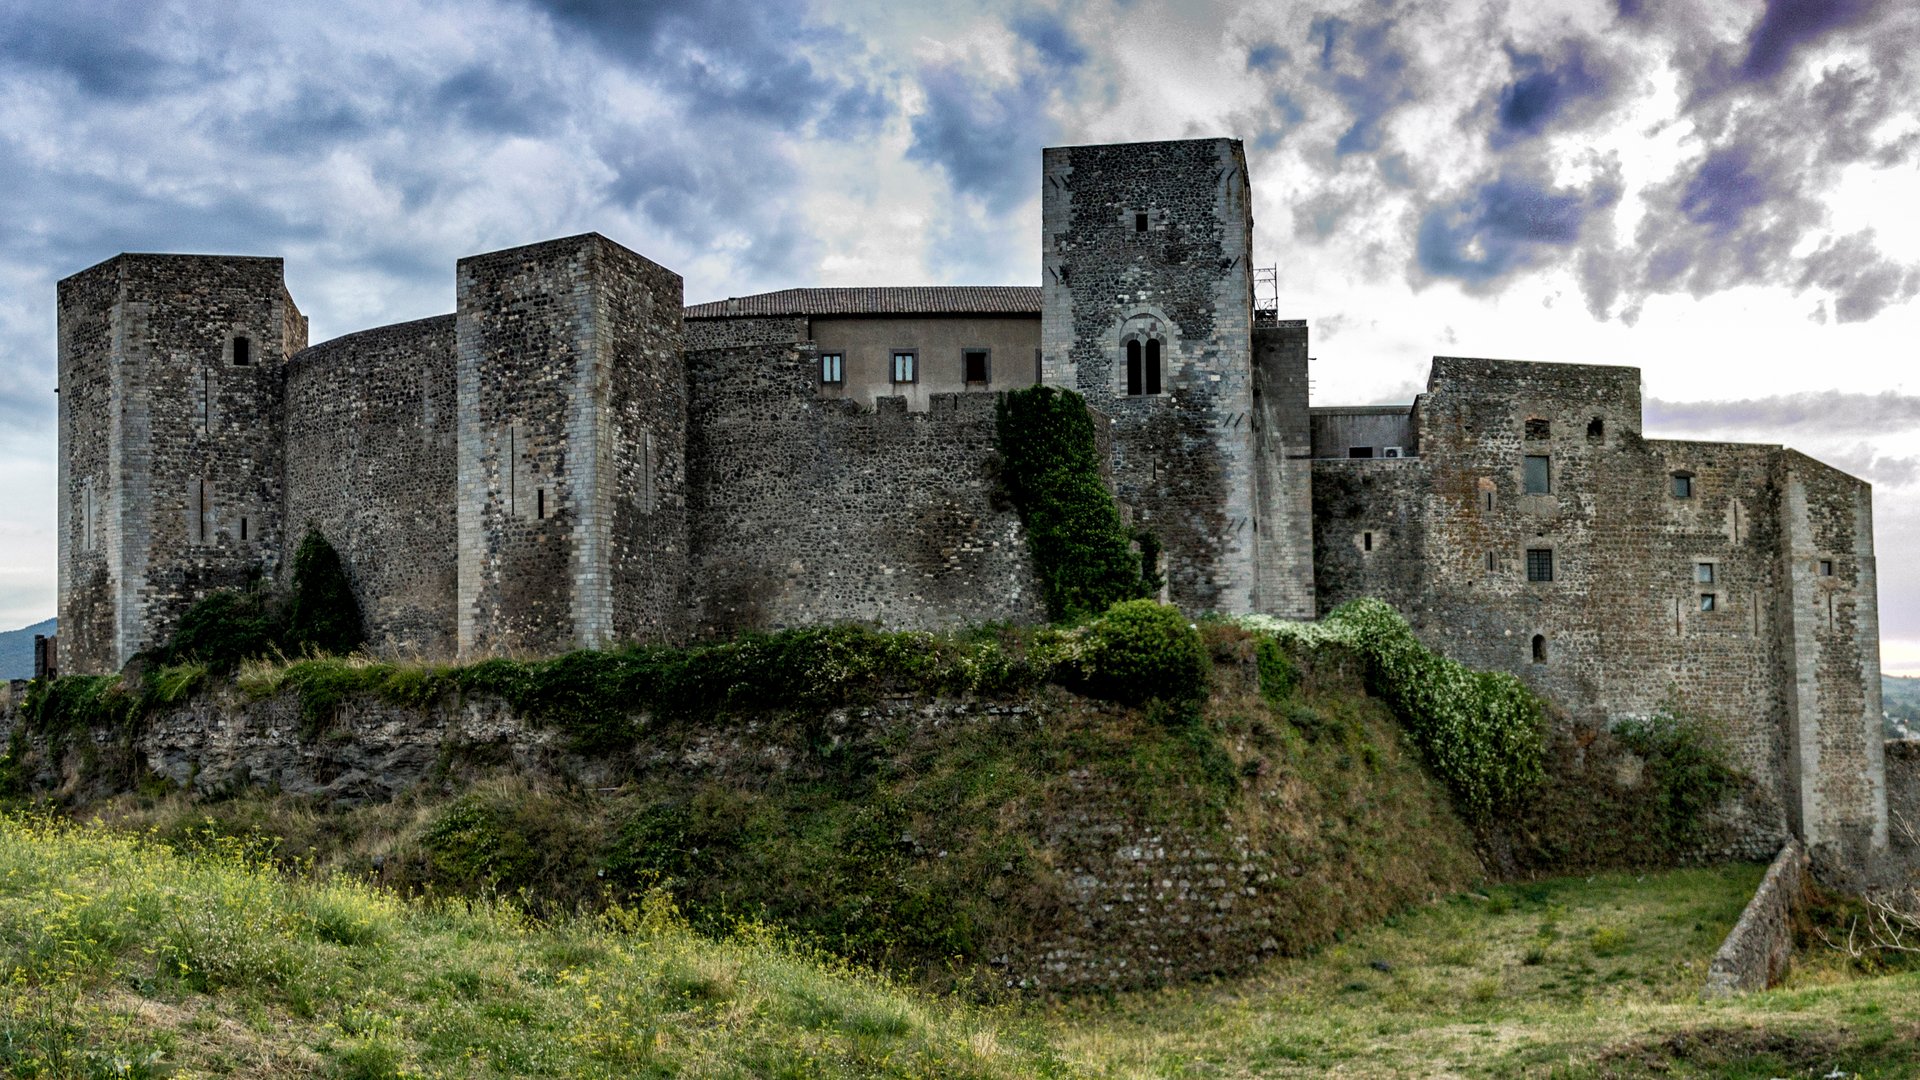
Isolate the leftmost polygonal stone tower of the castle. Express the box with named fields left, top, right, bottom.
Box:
left=60, top=256, right=307, bottom=673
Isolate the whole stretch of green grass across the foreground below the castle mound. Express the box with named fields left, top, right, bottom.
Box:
left=0, top=819, right=1920, bottom=1078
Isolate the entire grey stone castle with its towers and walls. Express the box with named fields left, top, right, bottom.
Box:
left=60, top=138, right=1887, bottom=865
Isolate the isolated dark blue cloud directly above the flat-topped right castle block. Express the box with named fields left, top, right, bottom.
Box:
left=1415, top=173, right=1619, bottom=288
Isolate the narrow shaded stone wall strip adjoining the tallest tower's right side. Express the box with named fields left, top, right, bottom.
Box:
left=1252, top=321, right=1315, bottom=619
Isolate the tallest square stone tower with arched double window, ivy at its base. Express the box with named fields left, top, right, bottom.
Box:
left=1041, top=138, right=1260, bottom=611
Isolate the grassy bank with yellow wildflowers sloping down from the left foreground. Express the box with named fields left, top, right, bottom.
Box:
left=0, top=817, right=1062, bottom=1078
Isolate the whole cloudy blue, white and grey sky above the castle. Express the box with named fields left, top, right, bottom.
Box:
left=0, top=0, right=1920, bottom=673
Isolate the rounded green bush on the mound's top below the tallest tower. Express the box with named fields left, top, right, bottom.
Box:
left=1081, top=600, right=1208, bottom=705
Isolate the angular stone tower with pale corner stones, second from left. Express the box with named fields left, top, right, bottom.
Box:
left=455, top=233, right=685, bottom=655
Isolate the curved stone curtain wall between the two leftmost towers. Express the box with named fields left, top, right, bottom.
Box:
left=280, top=315, right=457, bottom=657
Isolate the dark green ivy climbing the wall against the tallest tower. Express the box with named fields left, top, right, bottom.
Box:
left=996, top=386, right=1160, bottom=621
